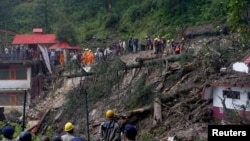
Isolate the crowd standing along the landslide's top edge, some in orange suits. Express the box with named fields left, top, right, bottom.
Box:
left=49, top=36, right=185, bottom=66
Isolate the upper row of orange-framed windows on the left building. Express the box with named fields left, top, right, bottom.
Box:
left=0, top=66, right=27, bottom=80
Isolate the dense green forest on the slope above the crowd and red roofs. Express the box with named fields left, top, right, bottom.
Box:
left=0, top=0, right=249, bottom=47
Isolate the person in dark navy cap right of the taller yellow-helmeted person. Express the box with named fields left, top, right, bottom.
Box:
left=124, top=124, right=137, bottom=141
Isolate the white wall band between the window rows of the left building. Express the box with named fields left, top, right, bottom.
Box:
left=0, top=68, right=31, bottom=91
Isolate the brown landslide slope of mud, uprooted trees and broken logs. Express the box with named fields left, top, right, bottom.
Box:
left=20, top=25, right=249, bottom=141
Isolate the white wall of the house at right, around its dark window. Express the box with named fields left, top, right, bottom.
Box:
left=213, top=87, right=250, bottom=111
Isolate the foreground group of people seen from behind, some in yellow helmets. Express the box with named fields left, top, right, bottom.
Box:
left=1, top=110, right=137, bottom=141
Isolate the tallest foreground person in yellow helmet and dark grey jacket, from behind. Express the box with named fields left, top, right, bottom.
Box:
left=98, top=110, right=121, bottom=141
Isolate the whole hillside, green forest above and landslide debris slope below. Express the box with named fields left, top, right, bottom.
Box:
left=0, top=0, right=250, bottom=141
